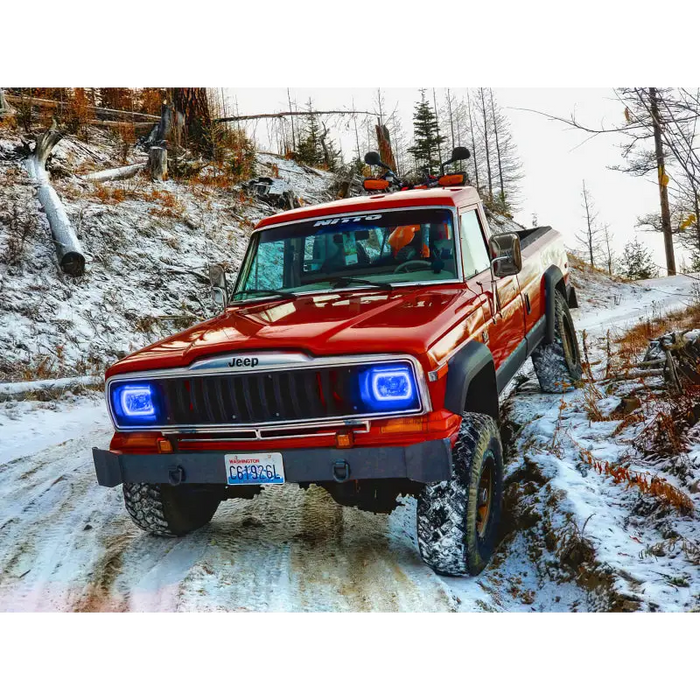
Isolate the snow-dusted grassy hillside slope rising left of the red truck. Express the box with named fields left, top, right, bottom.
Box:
left=0, top=131, right=334, bottom=381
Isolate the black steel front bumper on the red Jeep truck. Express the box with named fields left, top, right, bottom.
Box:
left=92, top=438, right=452, bottom=486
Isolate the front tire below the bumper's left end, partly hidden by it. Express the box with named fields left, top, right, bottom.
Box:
left=123, top=483, right=223, bottom=537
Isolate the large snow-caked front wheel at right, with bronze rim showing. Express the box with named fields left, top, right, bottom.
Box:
left=417, top=413, right=503, bottom=576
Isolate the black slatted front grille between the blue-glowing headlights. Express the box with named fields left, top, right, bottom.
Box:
left=155, top=366, right=366, bottom=426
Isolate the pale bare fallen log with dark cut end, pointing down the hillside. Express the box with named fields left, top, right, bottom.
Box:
left=25, top=122, right=85, bottom=277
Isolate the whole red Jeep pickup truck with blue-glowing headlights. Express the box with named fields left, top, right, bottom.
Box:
left=93, top=149, right=581, bottom=575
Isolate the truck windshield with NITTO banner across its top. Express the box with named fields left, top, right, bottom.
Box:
left=236, top=209, right=458, bottom=299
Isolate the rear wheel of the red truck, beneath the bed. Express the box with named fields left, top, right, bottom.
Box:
left=532, top=290, right=583, bottom=394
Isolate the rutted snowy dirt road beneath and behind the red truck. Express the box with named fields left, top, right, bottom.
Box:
left=0, top=278, right=693, bottom=614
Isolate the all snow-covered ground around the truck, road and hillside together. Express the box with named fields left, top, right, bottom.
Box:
left=0, top=127, right=700, bottom=614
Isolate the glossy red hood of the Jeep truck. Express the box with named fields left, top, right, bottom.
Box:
left=107, top=286, right=478, bottom=377
